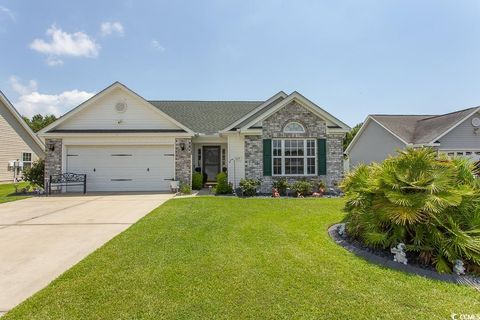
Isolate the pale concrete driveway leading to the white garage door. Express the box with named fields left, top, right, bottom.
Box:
left=0, top=194, right=172, bottom=315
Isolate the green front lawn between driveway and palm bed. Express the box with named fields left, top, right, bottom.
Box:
left=4, top=197, right=480, bottom=320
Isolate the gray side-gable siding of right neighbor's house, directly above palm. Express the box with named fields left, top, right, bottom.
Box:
left=349, top=120, right=405, bottom=168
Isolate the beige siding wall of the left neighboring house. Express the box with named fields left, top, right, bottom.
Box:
left=0, top=102, right=38, bottom=182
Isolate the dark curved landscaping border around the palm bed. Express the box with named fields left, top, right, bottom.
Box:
left=328, top=223, right=480, bottom=291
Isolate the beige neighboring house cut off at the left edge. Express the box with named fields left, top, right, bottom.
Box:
left=0, top=91, right=45, bottom=183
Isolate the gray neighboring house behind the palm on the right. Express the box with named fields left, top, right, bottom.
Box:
left=345, top=107, right=480, bottom=168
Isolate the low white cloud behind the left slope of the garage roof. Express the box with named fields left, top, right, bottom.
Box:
left=9, top=76, right=94, bottom=117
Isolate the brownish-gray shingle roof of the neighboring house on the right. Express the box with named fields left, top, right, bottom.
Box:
left=370, top=107, right=478, bottom=144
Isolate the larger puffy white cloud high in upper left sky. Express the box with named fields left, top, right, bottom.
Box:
left=30, top=25, right=100, bottom=65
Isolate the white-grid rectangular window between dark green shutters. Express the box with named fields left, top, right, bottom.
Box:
left=272, top=139, right=317, bottom=176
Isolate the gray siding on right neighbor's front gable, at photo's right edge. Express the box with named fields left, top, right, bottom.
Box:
left=439, top=113, right=480, bottom=150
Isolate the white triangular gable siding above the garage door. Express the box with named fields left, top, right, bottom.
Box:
left=56, top=88, right=180, bottom=130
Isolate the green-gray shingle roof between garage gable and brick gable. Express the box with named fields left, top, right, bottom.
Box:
left=149, top=100, right=263, bottom=133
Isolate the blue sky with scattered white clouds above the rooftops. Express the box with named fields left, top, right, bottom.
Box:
left=0, top=0, right=480, bottom=125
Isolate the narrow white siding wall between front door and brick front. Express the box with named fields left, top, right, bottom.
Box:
left=227, top=135, right=245, bottom=187
